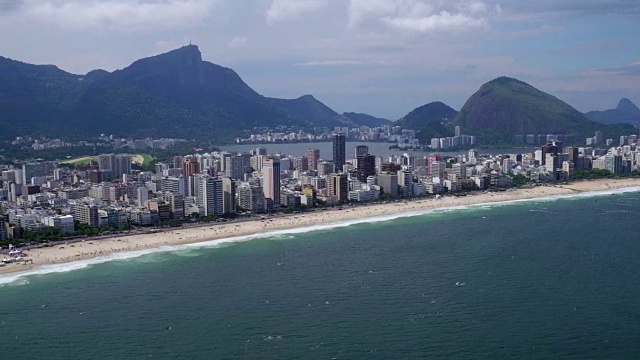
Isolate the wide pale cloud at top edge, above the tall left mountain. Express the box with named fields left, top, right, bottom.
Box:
left=26, top=0, right=218, bottom=31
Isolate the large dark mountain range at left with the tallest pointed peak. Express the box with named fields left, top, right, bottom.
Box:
left=0, top=45, right=344, bottom=140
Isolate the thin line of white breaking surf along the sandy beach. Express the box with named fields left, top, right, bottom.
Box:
left=0, top=187, right=640, bottom=286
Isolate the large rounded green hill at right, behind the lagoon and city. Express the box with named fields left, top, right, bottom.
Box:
left=450, top=77, right=637, bottom=144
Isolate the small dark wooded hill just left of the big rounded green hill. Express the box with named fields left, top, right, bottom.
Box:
left=393, top=101, right=458, bottom=143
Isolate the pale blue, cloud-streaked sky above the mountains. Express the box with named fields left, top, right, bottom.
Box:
left=0, top=0, right=640, bottom=119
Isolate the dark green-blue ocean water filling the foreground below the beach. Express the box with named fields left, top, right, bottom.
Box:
left=0, top=193, right=640, bottom=359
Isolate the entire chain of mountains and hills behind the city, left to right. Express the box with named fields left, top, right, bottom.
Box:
left=0, top=45, right=640, bottom=144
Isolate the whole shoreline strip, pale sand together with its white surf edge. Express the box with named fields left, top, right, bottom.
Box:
left=0, top=179, right=640, bottom=283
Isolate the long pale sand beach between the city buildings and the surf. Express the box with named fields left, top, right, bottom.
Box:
left=0, top=179, right=640, bottom=274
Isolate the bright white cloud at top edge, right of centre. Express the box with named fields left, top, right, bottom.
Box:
left=349, top=0, right=499, bottom=33
